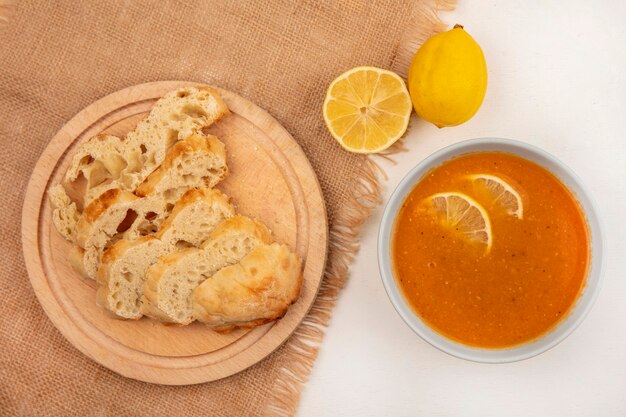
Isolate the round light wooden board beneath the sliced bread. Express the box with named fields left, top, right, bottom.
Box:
left=22, top=81, right=328, bottom=385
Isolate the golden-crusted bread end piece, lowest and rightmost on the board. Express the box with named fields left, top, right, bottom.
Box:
left=193, top=243, right=302, bottom=331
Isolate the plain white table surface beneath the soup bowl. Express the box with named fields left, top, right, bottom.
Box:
left=298, top=0, right=626, bottom=417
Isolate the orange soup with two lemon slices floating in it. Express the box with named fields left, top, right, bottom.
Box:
left=391, top=152, right=589, bottom=348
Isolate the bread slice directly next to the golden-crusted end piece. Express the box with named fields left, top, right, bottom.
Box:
left=143, top=216, right=271, bottom=324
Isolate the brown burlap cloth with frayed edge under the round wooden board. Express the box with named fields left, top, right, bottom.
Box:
left=0, top=0, right=452, bottom=416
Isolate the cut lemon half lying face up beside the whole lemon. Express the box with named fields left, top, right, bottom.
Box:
left=323, top=67, right=412, bottom=153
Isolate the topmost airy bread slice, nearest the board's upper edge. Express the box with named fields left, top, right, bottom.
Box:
left=65, top=87, right=229, bottom=206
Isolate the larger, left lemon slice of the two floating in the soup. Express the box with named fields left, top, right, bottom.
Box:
left=428, top=193, right=493, bottom=251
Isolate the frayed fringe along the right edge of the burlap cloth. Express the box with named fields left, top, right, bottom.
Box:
left=266, top=0, right=456, bottom=416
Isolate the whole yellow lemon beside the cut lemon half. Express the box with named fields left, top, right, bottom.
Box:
left=408, top=25, right=487, bottom=127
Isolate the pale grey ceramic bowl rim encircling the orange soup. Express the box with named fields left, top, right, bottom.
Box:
left=378, top=138, right=604, bottom=363
